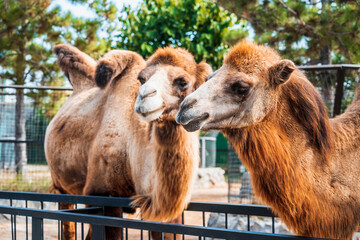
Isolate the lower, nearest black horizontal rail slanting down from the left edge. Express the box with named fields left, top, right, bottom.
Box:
left=0, top=206, right=324, bottom=240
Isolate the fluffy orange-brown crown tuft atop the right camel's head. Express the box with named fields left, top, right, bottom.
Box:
left=224, top=41, right=281, bottom=74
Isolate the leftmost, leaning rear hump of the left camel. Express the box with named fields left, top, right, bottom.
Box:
left=54, top=44, right=96, bottom=91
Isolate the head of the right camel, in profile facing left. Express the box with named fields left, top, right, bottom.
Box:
left=176, top=41, right=296, bottom=131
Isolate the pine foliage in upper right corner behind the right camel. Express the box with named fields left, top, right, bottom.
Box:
left=216, top=0, right=360, bottom=114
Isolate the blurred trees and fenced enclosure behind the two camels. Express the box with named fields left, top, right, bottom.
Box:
left=0, top=0, right=360, bottom=202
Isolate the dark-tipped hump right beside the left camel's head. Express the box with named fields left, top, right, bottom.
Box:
left=95, top=50, right=145, bottom=88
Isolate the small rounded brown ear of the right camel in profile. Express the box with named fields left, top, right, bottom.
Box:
left=269, top=59, right=296, bottom=86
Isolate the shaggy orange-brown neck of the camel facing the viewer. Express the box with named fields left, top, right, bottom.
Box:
left=145, top=121, right=199, bottom=220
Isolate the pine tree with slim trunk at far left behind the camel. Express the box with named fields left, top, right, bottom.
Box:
left=0, top=0, right=116, bottom=174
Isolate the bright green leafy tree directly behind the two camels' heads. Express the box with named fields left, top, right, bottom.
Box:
left=117, top=0, right=246, bottom=68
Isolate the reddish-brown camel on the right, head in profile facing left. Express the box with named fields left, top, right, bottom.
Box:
left=176, top=41, right=360, bottom=239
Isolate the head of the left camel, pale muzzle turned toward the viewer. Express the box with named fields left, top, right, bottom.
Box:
left=135, top=47, right=212, bottom=122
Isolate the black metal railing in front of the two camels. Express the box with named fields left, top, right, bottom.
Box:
left=0, top=191, right=330, bottom=240
